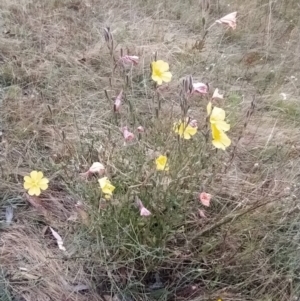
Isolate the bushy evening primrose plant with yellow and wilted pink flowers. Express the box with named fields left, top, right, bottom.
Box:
left=18, top=18, right=231, bottom=298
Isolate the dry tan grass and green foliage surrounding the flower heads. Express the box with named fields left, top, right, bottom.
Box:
left=0, top=0, right=300, bottom=301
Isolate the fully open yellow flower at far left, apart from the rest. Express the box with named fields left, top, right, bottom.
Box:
left=24, top=170, right=49, bottom=196
